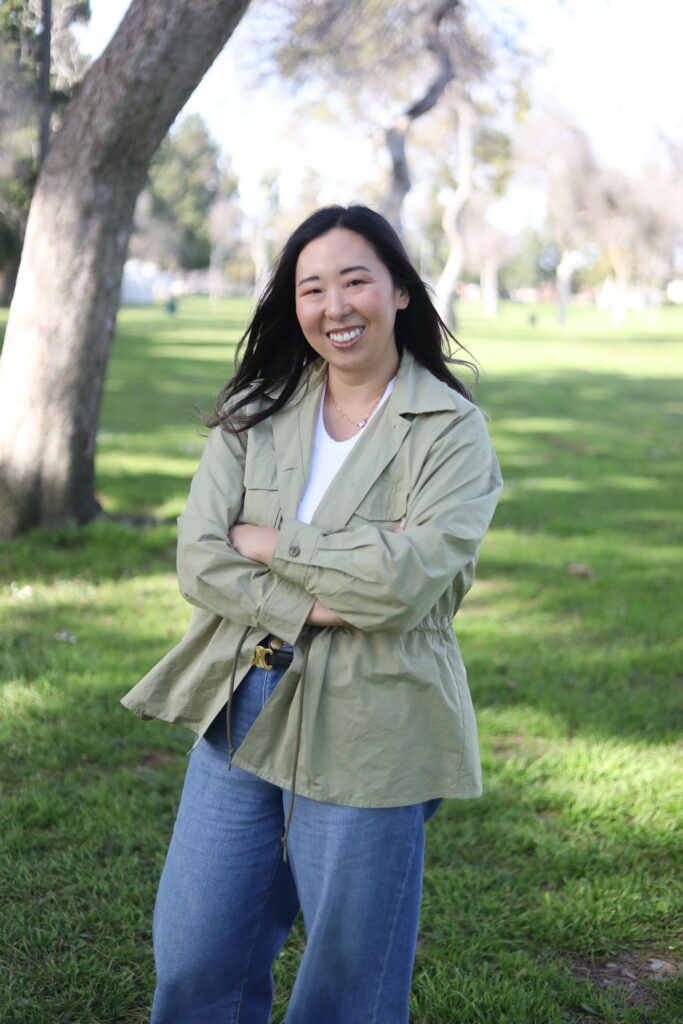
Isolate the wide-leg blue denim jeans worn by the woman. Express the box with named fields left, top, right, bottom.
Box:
left=152, top=668, right=439, bottom=1024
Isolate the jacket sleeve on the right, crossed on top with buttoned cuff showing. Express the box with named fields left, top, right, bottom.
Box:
left=270, top=407, right=503, bottom=631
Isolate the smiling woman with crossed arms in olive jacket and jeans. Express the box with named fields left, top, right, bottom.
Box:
left=124, top=206, right=501, bottom=1024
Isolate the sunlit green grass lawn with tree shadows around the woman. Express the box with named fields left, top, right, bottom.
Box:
left=0, top=300, right=683, bottom=1024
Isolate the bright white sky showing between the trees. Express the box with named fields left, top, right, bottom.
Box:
left=72, top=0, right=683, bottom=223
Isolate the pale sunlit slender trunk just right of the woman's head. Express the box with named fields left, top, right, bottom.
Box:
left=435, top=99, right=474, bottom=328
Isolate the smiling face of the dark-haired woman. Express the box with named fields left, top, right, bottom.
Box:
left=295, top=227, right=409, bottom=380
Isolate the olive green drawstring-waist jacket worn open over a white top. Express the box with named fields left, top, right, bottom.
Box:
left=123, top=354, right=502, bottom=807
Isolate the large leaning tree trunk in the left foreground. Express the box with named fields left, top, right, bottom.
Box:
left=0, top=0, right=249, bottom=537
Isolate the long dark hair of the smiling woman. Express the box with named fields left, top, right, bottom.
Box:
left=206, top=205, right=477, bottom=433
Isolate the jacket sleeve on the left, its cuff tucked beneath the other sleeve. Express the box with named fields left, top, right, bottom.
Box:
left=177, top=427, right=314, bottom=643
